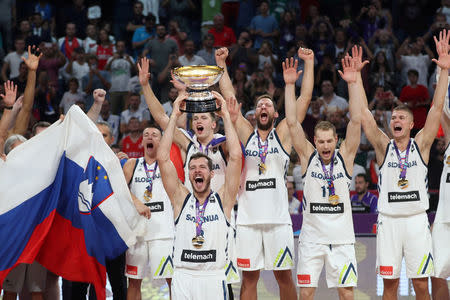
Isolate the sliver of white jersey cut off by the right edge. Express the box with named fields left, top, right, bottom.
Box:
left=434, top=145, right=450, bottom=223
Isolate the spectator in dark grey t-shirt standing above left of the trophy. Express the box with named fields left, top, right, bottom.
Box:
left=142, top=24, right=178, bottom=74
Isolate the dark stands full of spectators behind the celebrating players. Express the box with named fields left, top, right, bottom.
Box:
left=0, top=0, right=450, bottom=210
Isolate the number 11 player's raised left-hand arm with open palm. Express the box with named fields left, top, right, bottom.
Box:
left=282, top=57, right=314, bottom=171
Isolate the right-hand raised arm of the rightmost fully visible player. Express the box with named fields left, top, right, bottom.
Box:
left=415, top=30, right=450, bottom=162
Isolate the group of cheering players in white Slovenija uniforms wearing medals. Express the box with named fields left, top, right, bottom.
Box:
left=100, top=31, right=450, bottom=299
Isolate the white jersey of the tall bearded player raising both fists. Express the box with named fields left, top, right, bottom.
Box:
left=236, top=129, right=292, bottom=225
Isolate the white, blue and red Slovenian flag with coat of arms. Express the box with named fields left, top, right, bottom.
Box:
left=0, top=105, right=145, bottom=299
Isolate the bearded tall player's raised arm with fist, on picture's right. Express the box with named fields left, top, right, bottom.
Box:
left=296, top=48, right=314, bottom=123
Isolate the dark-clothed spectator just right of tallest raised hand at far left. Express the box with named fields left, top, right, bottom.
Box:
left=38, top=43, right=66, bottom=82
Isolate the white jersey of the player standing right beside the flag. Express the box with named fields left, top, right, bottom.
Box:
left=129, top=157, right=175, bottom=241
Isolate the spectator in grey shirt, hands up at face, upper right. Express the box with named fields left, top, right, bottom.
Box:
left=396, top=37, right=434, bottom=86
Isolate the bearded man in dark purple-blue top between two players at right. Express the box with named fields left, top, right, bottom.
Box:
left=350, top=173, right=378, bottom=214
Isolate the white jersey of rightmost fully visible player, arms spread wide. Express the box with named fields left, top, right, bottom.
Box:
left=378, top=139, right=429, bottom=216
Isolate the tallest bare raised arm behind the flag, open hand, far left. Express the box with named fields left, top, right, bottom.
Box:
left=13, top=46, right=42, bottom=135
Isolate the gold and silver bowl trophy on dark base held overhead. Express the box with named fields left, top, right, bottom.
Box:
left=173, top=65, right=223, bottom=113
